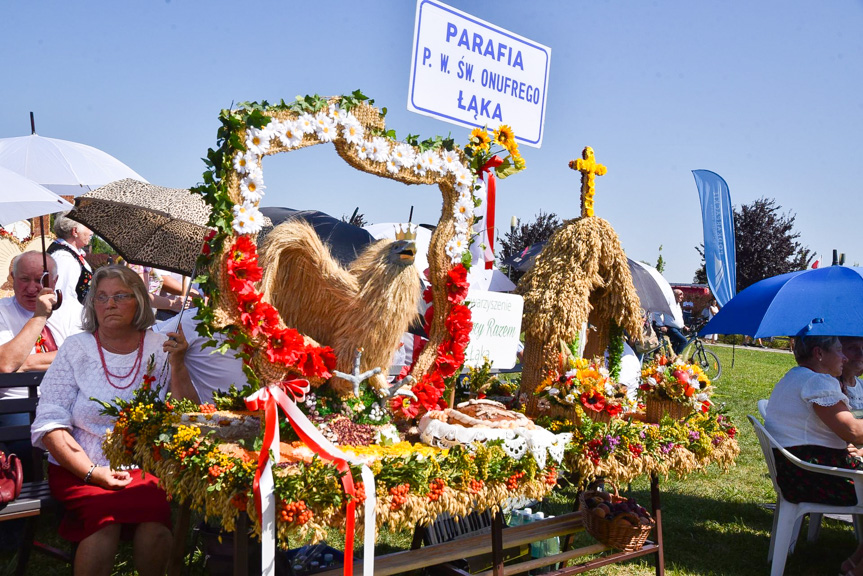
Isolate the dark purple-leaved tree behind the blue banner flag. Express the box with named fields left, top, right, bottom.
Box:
left=695, top=198, right=813, bottom=292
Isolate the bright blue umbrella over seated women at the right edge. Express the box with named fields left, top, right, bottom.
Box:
left=700, top=266, right=863, bottom=338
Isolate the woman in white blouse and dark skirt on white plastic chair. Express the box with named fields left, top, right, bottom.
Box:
left=764, top=336, right=863, bottom=575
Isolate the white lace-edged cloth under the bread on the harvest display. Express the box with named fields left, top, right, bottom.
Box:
left=419, top=414, right=572, bottom=468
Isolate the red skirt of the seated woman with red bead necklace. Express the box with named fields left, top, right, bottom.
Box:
left=48, top=464, right=171, bottom=542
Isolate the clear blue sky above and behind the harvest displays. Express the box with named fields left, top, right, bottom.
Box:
left=0, top=0, right=863, bottom=282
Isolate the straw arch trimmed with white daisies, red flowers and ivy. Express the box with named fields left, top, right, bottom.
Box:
left=194, top=91, right=524, bottom=413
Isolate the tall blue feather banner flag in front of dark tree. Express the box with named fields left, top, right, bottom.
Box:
left=692, top=170, right=737, bottom=306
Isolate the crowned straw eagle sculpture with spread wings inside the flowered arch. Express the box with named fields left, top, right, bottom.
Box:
left=261, top=219, right=420, bottom=395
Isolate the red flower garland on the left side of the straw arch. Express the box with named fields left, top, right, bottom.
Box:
left=226, top=236, right=336, bottom=379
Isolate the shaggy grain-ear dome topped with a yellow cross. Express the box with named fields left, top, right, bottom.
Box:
left=518, top=147, right=641, bottom=412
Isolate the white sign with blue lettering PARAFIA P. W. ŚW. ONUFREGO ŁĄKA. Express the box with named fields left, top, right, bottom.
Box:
left=408, top=0, right=551, bottom=148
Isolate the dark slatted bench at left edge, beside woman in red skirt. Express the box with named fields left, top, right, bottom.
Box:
left=0, top=372, right=72, bottom=574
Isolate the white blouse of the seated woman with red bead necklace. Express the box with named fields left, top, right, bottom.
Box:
left=30, top=330, right=167, bottom=466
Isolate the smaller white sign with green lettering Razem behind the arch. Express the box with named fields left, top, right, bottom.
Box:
left=465, top=289, right=524, bottom=370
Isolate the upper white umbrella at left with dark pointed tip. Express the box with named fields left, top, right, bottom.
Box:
left=0, top=113, right=146, bottom=196
